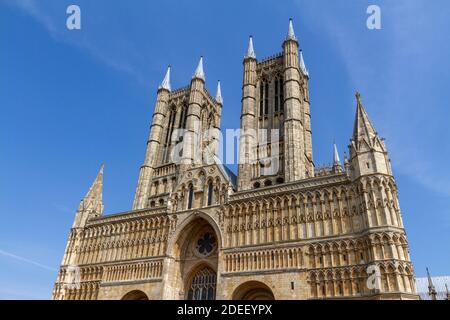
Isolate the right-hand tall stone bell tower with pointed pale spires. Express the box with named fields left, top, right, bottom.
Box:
left=238, top=19, right=314, bottom=191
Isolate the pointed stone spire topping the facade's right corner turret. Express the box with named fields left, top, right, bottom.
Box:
left=349, top=93, right=392, bottom=179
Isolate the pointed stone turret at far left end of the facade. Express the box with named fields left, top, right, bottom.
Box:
left=73, top=165, right=104, bottom=228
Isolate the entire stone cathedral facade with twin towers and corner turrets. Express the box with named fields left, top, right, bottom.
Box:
left=53, top=21, right=418, bottom=300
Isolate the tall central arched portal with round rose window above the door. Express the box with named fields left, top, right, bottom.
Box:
left=167, top=214, right=220, bottom=300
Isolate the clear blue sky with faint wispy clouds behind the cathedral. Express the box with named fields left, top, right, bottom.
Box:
left=0, top=0, right=450, bottom=299
